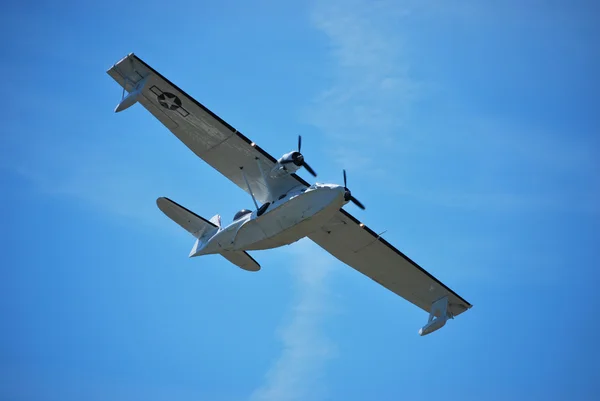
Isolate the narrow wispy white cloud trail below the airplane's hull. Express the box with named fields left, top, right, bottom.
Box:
left=251, top=239, right=336, bottom=401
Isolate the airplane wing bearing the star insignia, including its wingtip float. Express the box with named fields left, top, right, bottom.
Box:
left=107, top=53, right=310, bottom=203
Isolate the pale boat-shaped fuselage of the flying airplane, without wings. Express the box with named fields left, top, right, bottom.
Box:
left=190, top=184, right=346, bottom=256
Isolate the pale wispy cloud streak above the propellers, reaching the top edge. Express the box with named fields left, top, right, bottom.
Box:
left=309, top=0, right=421, bottom=176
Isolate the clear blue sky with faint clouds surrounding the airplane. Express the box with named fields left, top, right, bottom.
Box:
left=0, top=0, right=600, bottom=401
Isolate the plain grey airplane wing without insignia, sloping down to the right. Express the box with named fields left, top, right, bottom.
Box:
left=308, top=209, right=471, bottom=316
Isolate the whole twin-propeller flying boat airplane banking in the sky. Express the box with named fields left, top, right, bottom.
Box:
left=107, top=53, right=472, bottom=336
